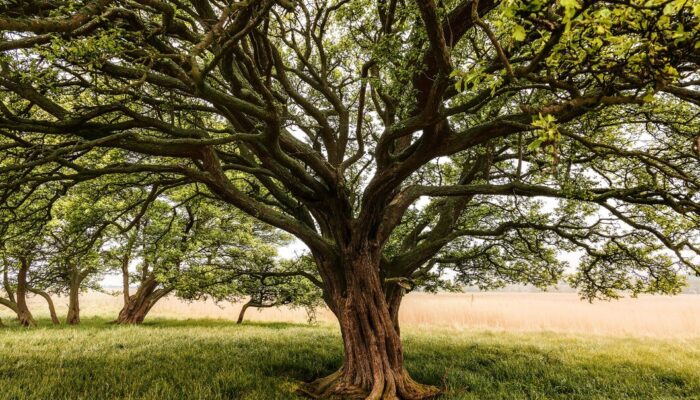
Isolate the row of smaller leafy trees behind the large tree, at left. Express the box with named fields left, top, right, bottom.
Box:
left=0, top=182, right=320, bottom=326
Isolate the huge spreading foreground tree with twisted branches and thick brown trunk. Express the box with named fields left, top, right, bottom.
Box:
left=0, top=0, right=700, bottom=399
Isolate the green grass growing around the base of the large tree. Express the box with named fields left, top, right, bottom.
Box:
left=0, top=319, right=700, bottom=400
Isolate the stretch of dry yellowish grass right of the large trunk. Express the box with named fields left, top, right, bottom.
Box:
left=401, top=293, right=700, bottom=337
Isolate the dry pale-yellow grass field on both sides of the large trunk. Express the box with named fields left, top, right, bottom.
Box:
left=5, top=293, right=700, bottom=338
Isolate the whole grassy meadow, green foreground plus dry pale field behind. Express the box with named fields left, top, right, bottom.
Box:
left=0, top=293, right=700, bottom=400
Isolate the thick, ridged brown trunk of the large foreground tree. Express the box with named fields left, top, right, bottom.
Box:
left=301, top=248, right=439, bottom=400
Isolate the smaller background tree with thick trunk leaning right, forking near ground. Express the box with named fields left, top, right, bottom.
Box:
left=110, top=190, right=292, bottom=324
